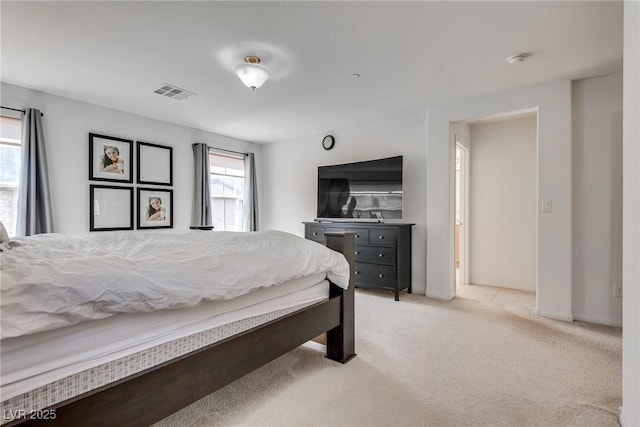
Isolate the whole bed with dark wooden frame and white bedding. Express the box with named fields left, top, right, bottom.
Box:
left=0, top=231, right=355, bottom=426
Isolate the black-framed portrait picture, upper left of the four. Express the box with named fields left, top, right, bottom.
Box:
left=89, top=133, right=133, bottom=183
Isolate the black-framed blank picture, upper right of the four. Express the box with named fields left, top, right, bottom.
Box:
left=137, top=141, right=173, bottom=186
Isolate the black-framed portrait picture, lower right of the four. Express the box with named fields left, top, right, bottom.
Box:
left=138, top=188, right=173, bottom=229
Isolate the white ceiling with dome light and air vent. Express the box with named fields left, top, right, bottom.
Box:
left=0, top=1, right=623, bottom=142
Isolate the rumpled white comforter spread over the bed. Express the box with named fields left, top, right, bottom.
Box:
left=0, top=231, right=349, bottom=338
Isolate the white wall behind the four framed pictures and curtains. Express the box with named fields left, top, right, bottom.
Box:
left=1, top=83, right=261, bottom=234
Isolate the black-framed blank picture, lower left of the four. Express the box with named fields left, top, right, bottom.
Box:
left=89, top=185, right=133, bottom=231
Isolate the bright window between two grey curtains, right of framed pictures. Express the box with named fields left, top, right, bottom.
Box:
left=209, top=151, right=246, bottom=231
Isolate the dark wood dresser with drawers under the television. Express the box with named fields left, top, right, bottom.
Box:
left=304, top=222, right=414, bottom=301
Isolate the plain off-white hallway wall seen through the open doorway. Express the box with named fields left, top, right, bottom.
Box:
left=469, top=115, right=537, bottom=292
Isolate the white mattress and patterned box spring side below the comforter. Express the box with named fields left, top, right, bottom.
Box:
left=0, top=274, right=330, bottom=423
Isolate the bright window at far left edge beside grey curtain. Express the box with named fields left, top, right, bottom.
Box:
left=0, top=115, right=22, bottom=237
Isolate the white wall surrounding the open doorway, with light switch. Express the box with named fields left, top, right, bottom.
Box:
left=426, top=81, right=573, bottom=321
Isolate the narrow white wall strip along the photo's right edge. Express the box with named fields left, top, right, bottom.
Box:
left=620, top=1, right=640, bottom=427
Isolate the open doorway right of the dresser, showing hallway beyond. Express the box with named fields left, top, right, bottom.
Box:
left=454, top=113, right=537, bottom=312
